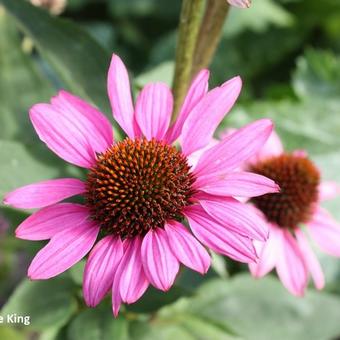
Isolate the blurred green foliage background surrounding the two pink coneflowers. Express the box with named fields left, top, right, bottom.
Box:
left=0, top=0, right=340, bottom=340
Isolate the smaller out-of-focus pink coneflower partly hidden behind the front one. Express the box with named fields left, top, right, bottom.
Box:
left=244, top=132, right=340, bottom=296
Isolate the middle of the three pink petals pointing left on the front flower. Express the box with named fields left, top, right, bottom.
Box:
left=15, top=203, right=89, bottom=241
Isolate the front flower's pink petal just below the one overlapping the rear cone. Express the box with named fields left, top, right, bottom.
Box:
left=199, top=198, right=268, bottom=241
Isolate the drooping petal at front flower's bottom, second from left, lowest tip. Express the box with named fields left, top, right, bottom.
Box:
left=112, top=237, right=149, bottom=309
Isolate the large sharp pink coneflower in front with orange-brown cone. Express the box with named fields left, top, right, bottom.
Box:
left=4, top=55, right=278, bottom=315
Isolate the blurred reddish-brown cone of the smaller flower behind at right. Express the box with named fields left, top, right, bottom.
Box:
left=250, top=154, right=320, bottom=229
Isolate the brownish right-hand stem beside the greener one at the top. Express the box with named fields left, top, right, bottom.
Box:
left=191, top=0, right=229, bottom=77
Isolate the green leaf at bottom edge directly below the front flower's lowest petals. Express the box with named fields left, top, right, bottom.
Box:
left=67, top=303, right=128, bottom=340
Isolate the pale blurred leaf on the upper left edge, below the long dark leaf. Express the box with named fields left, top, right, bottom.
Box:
left=0, top=7, right=53, bottom=143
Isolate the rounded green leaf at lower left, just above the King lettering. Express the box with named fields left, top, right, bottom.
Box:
left=1, top=276, right=77, bottom=330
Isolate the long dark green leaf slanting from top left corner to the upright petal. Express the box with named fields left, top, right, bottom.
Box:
left=0, top=0, right=122, bottom=138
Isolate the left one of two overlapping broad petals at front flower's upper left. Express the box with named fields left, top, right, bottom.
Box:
left=29, top=104, right=98, bottom=168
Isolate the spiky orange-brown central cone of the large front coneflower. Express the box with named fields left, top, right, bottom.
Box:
left=86, top=139, right=195, bottom=238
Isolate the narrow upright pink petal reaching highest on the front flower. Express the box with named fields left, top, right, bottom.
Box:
left=107, top=54, right=136, bottom=138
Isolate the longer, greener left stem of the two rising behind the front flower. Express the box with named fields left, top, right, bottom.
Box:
left=172, top=0, right=205, bottom=121
